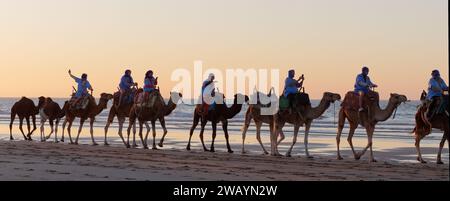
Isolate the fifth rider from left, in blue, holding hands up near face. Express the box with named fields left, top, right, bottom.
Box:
left=283, top=69, right=305, bottom=114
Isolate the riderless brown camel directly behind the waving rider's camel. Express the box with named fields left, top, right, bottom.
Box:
left=38, top=96, right=68, bottom=143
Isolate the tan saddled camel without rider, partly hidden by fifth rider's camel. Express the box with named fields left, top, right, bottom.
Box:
left=242, top=88, right=278, bottom=154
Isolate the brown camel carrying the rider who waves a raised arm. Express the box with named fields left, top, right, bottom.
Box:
left=63, top=93, right=113, bottom=145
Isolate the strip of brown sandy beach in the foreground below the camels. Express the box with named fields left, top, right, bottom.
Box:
left=0, top=140, right=449, bottom=181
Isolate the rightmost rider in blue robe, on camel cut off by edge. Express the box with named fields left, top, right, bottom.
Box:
left=425, top=70, right=448, bottom=126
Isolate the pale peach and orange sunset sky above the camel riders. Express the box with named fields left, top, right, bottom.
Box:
left=0, top=0, right=448, bottom=99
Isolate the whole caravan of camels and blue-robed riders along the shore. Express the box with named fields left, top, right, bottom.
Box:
left=9, top=67, right=449, bottom=164
